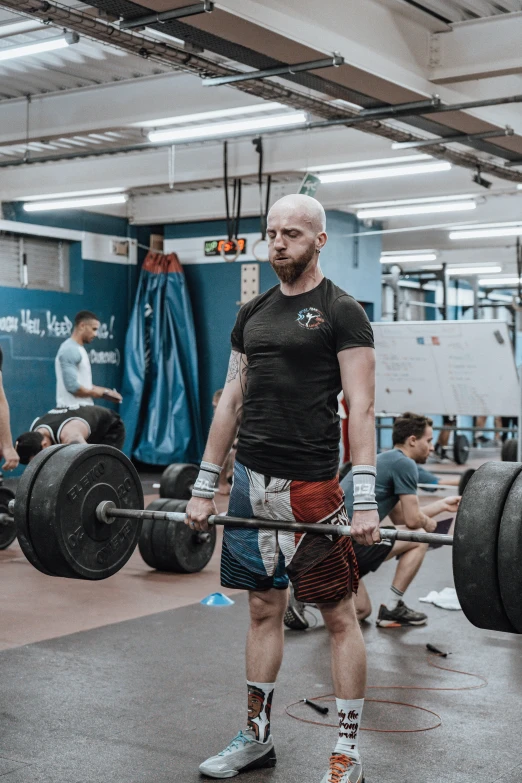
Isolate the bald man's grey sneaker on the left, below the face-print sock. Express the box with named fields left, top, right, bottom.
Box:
left=199, top=729, right=274, bottom=783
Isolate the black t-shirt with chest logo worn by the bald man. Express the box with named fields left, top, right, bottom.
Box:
left=232, top=278, right=373, bottom=481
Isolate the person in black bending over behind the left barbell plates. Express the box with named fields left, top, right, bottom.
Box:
left=16, top=405, right=125, bottom=465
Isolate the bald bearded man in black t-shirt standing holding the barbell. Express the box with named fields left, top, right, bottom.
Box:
left=186, top=195, right=380, bottom=783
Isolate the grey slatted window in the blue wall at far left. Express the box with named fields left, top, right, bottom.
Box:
left=0, top=233, right=70, bottom=292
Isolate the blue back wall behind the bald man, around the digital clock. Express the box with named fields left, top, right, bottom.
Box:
left=165, top=211, right=381, bottom=432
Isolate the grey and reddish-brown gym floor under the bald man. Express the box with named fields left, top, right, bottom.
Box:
left=0, top=451, right=522, bottom=783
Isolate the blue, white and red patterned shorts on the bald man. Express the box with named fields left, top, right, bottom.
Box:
left=221, top=461, right=359, bottom=603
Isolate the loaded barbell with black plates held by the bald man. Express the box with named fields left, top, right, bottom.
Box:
left=6, top=444, right=522, bottom=633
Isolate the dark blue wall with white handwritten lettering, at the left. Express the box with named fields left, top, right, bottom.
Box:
left=0, top=205, right=148, bottom=472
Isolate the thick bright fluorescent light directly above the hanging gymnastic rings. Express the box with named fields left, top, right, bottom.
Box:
left=149, top=112, right=307, bottom=143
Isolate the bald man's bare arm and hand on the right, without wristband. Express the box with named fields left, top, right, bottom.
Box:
left=337, top=348, right=380, bottom=546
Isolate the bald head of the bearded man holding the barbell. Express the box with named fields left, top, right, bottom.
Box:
left=266, top=194, right=327, bottom=284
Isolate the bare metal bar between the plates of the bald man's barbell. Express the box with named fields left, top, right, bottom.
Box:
left=96, top=500, right=453, bottom=546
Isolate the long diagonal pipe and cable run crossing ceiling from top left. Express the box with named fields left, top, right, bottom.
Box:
left=0, top=0, right=522, bottom=182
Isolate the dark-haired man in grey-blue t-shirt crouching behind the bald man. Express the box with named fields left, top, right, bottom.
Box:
left=285, top=413, right=460, bottom=630
